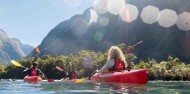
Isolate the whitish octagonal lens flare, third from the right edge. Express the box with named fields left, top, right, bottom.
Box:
left=141, top=6, right=160, bottom=24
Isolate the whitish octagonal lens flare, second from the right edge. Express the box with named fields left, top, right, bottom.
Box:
left=158, top=9, right=177, bottom=28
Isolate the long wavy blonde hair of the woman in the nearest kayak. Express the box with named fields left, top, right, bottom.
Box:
left=108, top=46, right=125, bottom=61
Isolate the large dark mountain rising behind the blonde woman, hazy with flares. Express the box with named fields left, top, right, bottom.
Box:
left=30, top=0, right=190, bottom=63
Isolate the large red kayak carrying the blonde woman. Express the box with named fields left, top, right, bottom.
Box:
left=90, top=69, right=149, bottom=84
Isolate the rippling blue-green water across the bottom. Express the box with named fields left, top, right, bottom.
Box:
left=0, top=80, right=190, bottom=94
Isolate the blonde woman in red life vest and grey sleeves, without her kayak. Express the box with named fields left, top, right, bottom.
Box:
left=96, top=46, right=130, bottom=73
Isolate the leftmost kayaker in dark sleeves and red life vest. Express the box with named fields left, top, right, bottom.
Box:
left=23, top=62, right=45, bottom=78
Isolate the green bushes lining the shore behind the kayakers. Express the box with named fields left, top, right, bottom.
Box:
left=0, top=44, right=190, bottom=81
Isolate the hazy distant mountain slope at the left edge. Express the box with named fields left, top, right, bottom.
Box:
left=0, top=29, right=34, bottom=65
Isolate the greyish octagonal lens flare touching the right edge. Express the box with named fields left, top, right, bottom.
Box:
left=176, top=12, right=190, bottom=31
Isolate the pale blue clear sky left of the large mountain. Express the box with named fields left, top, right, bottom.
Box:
left=0, top=0, right=93, bottom=47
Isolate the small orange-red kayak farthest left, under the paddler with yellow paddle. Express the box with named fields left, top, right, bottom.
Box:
left=24, top=76, right=42, bottom=83
